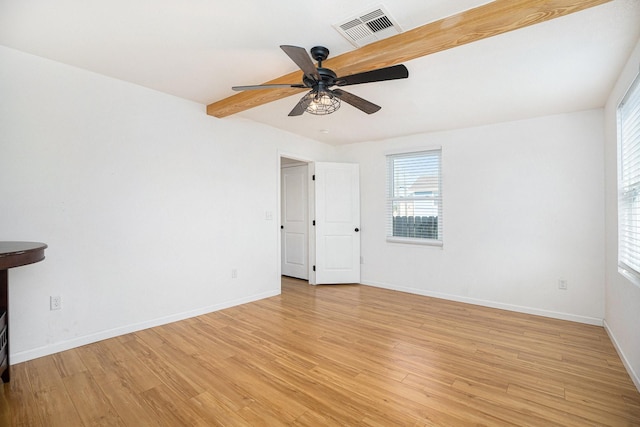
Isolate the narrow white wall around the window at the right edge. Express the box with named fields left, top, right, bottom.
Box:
left=605, top=37, right=640, bottom=389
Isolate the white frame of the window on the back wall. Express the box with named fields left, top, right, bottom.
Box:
left=385, top=147, right=444, bottom=247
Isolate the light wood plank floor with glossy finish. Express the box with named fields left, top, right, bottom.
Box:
left=0, top=278, right=640, bottom=427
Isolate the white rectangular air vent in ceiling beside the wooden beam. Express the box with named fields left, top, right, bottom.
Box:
left=333, top=6, right=402, bottom=47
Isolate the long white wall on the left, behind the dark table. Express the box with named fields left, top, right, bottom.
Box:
left=0, top=47, right=334, bottom=363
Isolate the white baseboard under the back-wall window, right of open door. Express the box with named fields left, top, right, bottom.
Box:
left=364, top=281, right=602, bottom=326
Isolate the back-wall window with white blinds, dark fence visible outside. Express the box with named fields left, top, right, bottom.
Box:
left=387, top=149, right=442, bottom=245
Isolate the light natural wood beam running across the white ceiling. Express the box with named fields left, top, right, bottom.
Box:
left=207, top=0, right=612, bottom=117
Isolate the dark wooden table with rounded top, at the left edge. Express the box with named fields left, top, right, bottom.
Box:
left=0, top=242, right=47, bottom=383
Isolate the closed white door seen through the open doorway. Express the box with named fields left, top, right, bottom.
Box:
left=280, top=164, right=309, bottom=280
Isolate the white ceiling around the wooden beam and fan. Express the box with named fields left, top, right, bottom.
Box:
left=0, top=0, right=640, bottom=144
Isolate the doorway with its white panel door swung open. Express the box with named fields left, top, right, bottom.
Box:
left=279, top=155, right=360, bottom=285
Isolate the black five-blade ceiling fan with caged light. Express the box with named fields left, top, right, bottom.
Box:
left=232, top=45, right=409, bottom=116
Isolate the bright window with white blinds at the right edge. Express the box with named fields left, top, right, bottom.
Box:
left=618, top=77, right=640, bottom=284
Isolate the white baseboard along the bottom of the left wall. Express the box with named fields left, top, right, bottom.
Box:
left=10, top=289, right=280, bottom=365
